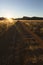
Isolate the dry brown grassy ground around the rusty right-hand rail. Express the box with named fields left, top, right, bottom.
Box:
left=0, top=20, right=43, bottom=65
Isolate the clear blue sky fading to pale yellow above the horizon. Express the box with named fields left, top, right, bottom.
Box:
left=0, top=0, right=43, bottom=18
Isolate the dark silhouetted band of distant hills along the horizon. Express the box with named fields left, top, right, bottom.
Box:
left=0, top=16, right=43, bottom=20
